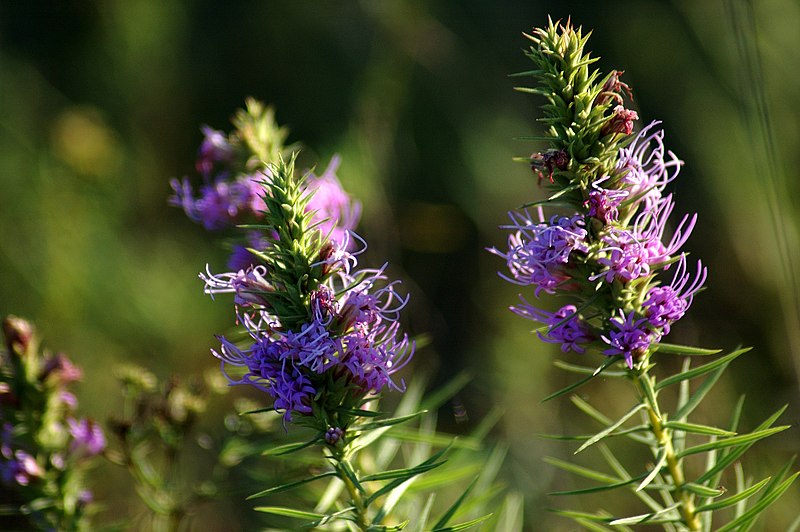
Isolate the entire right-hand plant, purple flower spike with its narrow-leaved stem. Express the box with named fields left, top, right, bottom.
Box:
left=490, top=21, right=797, bottom=531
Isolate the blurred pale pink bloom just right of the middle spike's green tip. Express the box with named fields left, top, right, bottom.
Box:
left=303, top=156, right=361, bottom=249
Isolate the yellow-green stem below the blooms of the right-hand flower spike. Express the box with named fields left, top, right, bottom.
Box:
left=634, top=367, right=701, bottom=532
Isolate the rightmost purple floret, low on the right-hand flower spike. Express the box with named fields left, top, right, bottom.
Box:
left=642, top=255, right=708, bottom=334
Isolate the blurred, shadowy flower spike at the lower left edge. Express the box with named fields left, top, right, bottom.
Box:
left=0, top=316, right=106, bottom=530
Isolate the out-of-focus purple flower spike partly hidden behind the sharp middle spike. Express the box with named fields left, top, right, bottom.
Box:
left=169, top=100, right=360, bottom=270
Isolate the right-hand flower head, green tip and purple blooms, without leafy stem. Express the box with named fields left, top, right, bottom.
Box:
left=490, top=23, right=707, bottom=368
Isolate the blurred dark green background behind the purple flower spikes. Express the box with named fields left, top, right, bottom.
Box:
left=0, top=0, right=800, bottom=530
